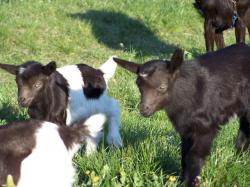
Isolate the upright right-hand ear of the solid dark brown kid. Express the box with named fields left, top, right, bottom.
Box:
left=168, top=48, right=184, bottom=73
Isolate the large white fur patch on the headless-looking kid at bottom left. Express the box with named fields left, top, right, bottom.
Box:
left=17, top=122, right=76, bottom=187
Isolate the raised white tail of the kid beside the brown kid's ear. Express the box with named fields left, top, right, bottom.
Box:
left=99, top=56, right=117, bottom=84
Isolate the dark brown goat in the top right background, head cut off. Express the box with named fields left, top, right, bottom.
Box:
left=194, top=0, right=250, bottom=51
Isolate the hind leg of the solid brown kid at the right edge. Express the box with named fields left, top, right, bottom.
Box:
left=236, top=116, right=250, bottom=151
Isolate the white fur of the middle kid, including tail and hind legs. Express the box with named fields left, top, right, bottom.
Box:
left=57, top=57, right=122, bottom=154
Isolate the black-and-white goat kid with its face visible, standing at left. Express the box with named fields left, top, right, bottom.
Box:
left=0, top=58, right=122, bottom=154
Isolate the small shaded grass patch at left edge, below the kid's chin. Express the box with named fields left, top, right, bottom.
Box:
left=0, top=102, right=27, bottom=123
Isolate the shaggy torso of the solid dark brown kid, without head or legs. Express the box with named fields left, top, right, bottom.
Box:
left=169, top=44, right=250, bottom=134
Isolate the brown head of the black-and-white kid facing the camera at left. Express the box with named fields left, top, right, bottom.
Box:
left=0, top=61, right=56, bottom=107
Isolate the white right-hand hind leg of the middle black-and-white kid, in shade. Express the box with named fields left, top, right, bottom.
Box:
left=107, top=98, right=122, bottom=147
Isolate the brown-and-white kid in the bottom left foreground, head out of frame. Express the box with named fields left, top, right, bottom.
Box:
left=0, top=114, right=106, bottom=187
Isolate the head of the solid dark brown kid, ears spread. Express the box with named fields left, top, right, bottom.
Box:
left=114, top=49, right=183, bottom=117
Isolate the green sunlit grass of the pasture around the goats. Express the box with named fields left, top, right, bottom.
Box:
left=0, top=0, right=250, bottom=187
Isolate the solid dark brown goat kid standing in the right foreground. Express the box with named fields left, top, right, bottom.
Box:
left=114, top=44, right=250, bottom=186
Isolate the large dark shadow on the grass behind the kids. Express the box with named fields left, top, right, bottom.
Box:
left=68, top=10, right=174, bottom=56
